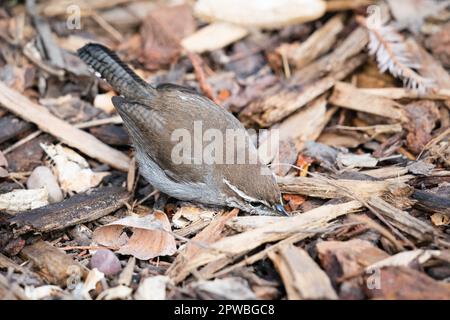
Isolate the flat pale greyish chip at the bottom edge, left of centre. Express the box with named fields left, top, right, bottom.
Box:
left=190, top=277, right=256, bottom=300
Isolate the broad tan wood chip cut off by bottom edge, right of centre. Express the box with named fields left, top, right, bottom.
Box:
left=269, top=245, right=337, bottom=300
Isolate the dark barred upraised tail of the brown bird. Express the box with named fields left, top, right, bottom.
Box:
left=77, top=43, right=155, bottom=98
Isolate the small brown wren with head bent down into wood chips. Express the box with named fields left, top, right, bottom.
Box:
left=78, top=43, right=286, bottom=215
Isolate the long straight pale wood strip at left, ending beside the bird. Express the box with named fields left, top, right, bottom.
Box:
left=0, top=81, right=129, bottom=171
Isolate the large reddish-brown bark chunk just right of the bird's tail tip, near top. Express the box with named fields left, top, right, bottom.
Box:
left=141, top=4, right=196, bottom=69
